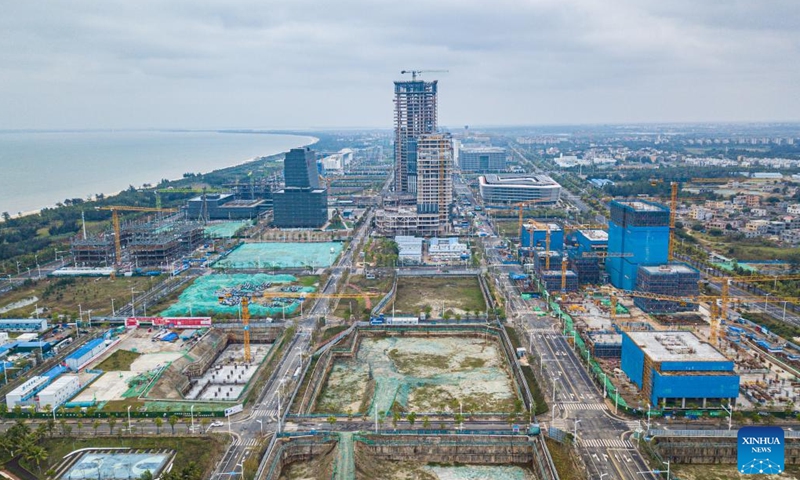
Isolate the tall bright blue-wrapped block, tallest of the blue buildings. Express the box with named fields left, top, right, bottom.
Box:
left=606, top=200, right=669, bottom=290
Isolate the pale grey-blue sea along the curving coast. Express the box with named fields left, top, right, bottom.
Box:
left=0, top=131, right=316, bottom=215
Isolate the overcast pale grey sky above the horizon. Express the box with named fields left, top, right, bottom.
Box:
left=0, top=0, right=800, bottom=129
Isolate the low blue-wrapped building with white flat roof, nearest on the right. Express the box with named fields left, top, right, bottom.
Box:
left=620, top=331, right=739, bottom=408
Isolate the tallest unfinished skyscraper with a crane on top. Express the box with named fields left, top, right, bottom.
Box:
left=394, top=80, right=438, bottom=193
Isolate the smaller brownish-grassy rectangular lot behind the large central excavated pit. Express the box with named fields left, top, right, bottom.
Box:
left=389, top=277, right=486, bottom=318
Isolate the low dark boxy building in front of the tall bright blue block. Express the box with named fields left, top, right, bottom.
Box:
left=633, top=263, right=700, bottom=313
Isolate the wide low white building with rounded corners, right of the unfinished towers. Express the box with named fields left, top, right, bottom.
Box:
left=478, top=174, right=561, bottom=205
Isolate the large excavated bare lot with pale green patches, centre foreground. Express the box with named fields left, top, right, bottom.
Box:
left=316, top=335, right=517, bottom=415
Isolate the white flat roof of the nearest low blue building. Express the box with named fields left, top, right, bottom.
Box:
left=626, top=332, right=729, bottom=362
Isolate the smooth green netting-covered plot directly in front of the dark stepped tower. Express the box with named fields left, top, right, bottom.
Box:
left=213, top=242, right=342, bottom=269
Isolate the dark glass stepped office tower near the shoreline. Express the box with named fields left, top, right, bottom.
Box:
left=272, top=147, right=328, bottom=228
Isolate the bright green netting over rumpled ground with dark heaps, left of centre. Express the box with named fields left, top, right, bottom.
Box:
left=161, top=273, right=315, bottom=317
